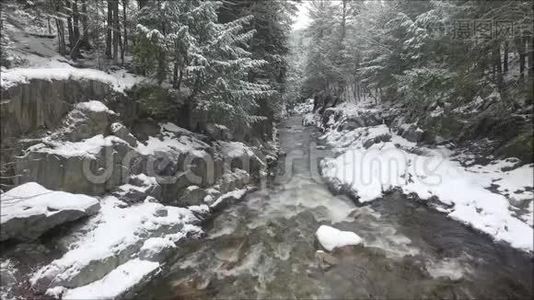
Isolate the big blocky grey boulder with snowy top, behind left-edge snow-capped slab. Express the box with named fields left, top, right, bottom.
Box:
left=15, top=135, right=133, bottom=195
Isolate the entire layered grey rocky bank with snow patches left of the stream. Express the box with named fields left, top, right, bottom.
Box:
left=1, top=74, right=276, bottom=298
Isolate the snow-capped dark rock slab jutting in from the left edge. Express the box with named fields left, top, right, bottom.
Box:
left=0, top=182, right=100, bottom=241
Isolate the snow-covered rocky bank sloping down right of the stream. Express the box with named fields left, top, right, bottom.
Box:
left=314, top=104, right=534, bottom=251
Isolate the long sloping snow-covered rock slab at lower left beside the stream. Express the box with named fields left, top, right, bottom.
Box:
left=30, top=196, right=207, bottom=292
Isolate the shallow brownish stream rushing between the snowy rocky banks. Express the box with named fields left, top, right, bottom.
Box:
left=138, top=117, right=533, bottom=299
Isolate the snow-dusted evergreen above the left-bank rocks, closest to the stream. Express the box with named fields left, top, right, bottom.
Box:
left=188, top=8, right=275, bottom=126
